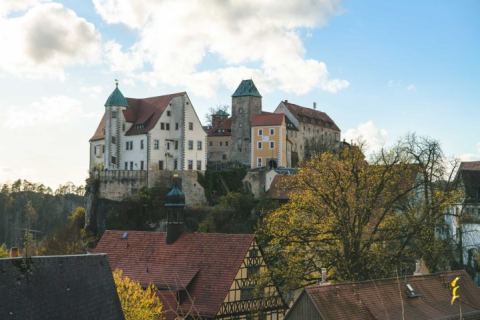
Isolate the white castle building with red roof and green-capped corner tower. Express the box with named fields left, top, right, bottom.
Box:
left=90, top=83, right=207, bottom=172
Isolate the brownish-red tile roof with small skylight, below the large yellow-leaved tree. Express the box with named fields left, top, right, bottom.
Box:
left=292, top=271, right=480, bottom=320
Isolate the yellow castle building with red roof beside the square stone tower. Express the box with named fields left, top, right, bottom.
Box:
left=250, top=112, right=290, bottom=168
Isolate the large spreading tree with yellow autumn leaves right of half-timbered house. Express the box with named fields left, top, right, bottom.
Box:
left=259, top=138, right=464, bottom=288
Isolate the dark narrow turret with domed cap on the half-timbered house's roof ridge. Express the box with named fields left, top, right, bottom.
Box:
left=165, top=175, right=185, bottom=244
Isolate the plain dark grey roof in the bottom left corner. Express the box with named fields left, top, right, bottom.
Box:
left=0, top=254, right=124, bottom=320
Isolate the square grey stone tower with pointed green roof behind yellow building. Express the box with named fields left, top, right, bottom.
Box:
left=231, top=80, right=262, bottom=166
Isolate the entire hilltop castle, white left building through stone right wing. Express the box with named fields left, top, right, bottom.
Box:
left=90, top=80, right=340, bottom=206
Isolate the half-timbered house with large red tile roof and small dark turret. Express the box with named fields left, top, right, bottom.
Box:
left=94, top=184, right=287, bottom=320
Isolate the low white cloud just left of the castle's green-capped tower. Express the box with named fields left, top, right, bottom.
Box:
left=3, top=95, right=82, bottom=129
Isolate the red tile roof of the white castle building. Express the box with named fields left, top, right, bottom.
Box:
left=90, top=92, right=186, bottom=141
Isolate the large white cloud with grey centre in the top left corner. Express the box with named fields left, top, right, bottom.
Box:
left=0, top=0, right=100, bottom=77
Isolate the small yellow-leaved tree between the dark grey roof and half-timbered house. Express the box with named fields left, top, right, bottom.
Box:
left=113, top=269, right=164, bottom=320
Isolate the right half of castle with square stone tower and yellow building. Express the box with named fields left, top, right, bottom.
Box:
left=207, top=80, right=341, bottom=168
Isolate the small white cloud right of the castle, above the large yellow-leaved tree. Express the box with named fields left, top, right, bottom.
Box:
left=345, top=120, right=388, bottom=153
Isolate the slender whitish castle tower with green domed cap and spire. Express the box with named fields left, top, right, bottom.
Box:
left=104, top=80, right=128, bottom=170
